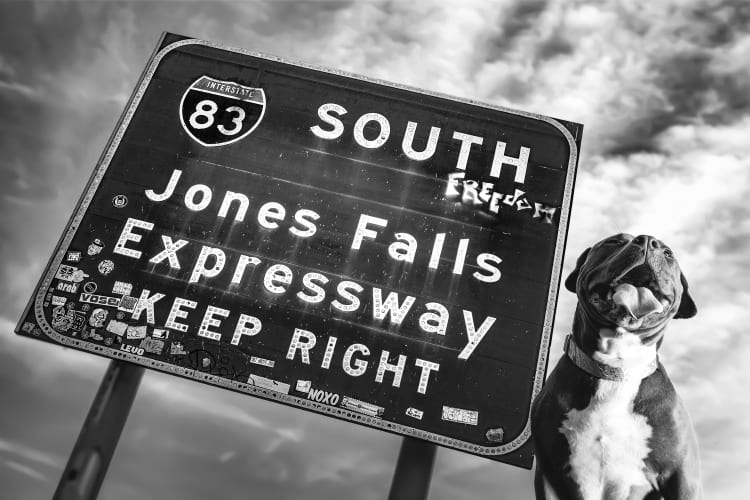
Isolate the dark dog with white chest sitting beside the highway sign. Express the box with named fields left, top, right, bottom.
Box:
left=531, top=234, right=703, bottom=500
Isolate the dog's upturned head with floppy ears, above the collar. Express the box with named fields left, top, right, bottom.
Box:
left=565, top=234, right=696, bottom=333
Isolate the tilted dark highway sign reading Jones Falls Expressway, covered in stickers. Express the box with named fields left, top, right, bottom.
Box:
left=17, top=34, right=582, bottom=467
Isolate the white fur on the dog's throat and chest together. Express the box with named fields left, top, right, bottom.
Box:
left=560, top=330, right=656, bottom=500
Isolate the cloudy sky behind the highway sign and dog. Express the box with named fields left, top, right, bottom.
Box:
left=0, top=0, right=750, bottom=500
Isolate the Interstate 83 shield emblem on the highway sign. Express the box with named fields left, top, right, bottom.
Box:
left=180, top=75, right=266, bottom=147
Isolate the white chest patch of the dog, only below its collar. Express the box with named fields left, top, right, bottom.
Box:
left=560, top=334, right=652, bottom=500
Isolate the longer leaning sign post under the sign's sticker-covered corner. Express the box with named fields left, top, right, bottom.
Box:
left=52, top=360, right=144, bottom=500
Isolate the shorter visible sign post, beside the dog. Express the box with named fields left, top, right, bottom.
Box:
left=388, top=437, right=437, bottom=500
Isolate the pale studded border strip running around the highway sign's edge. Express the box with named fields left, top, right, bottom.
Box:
left=16, top=33, right=578, bottom=457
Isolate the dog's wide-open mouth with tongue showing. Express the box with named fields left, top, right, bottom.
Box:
left=590, top=264, right=670, bottom=324
